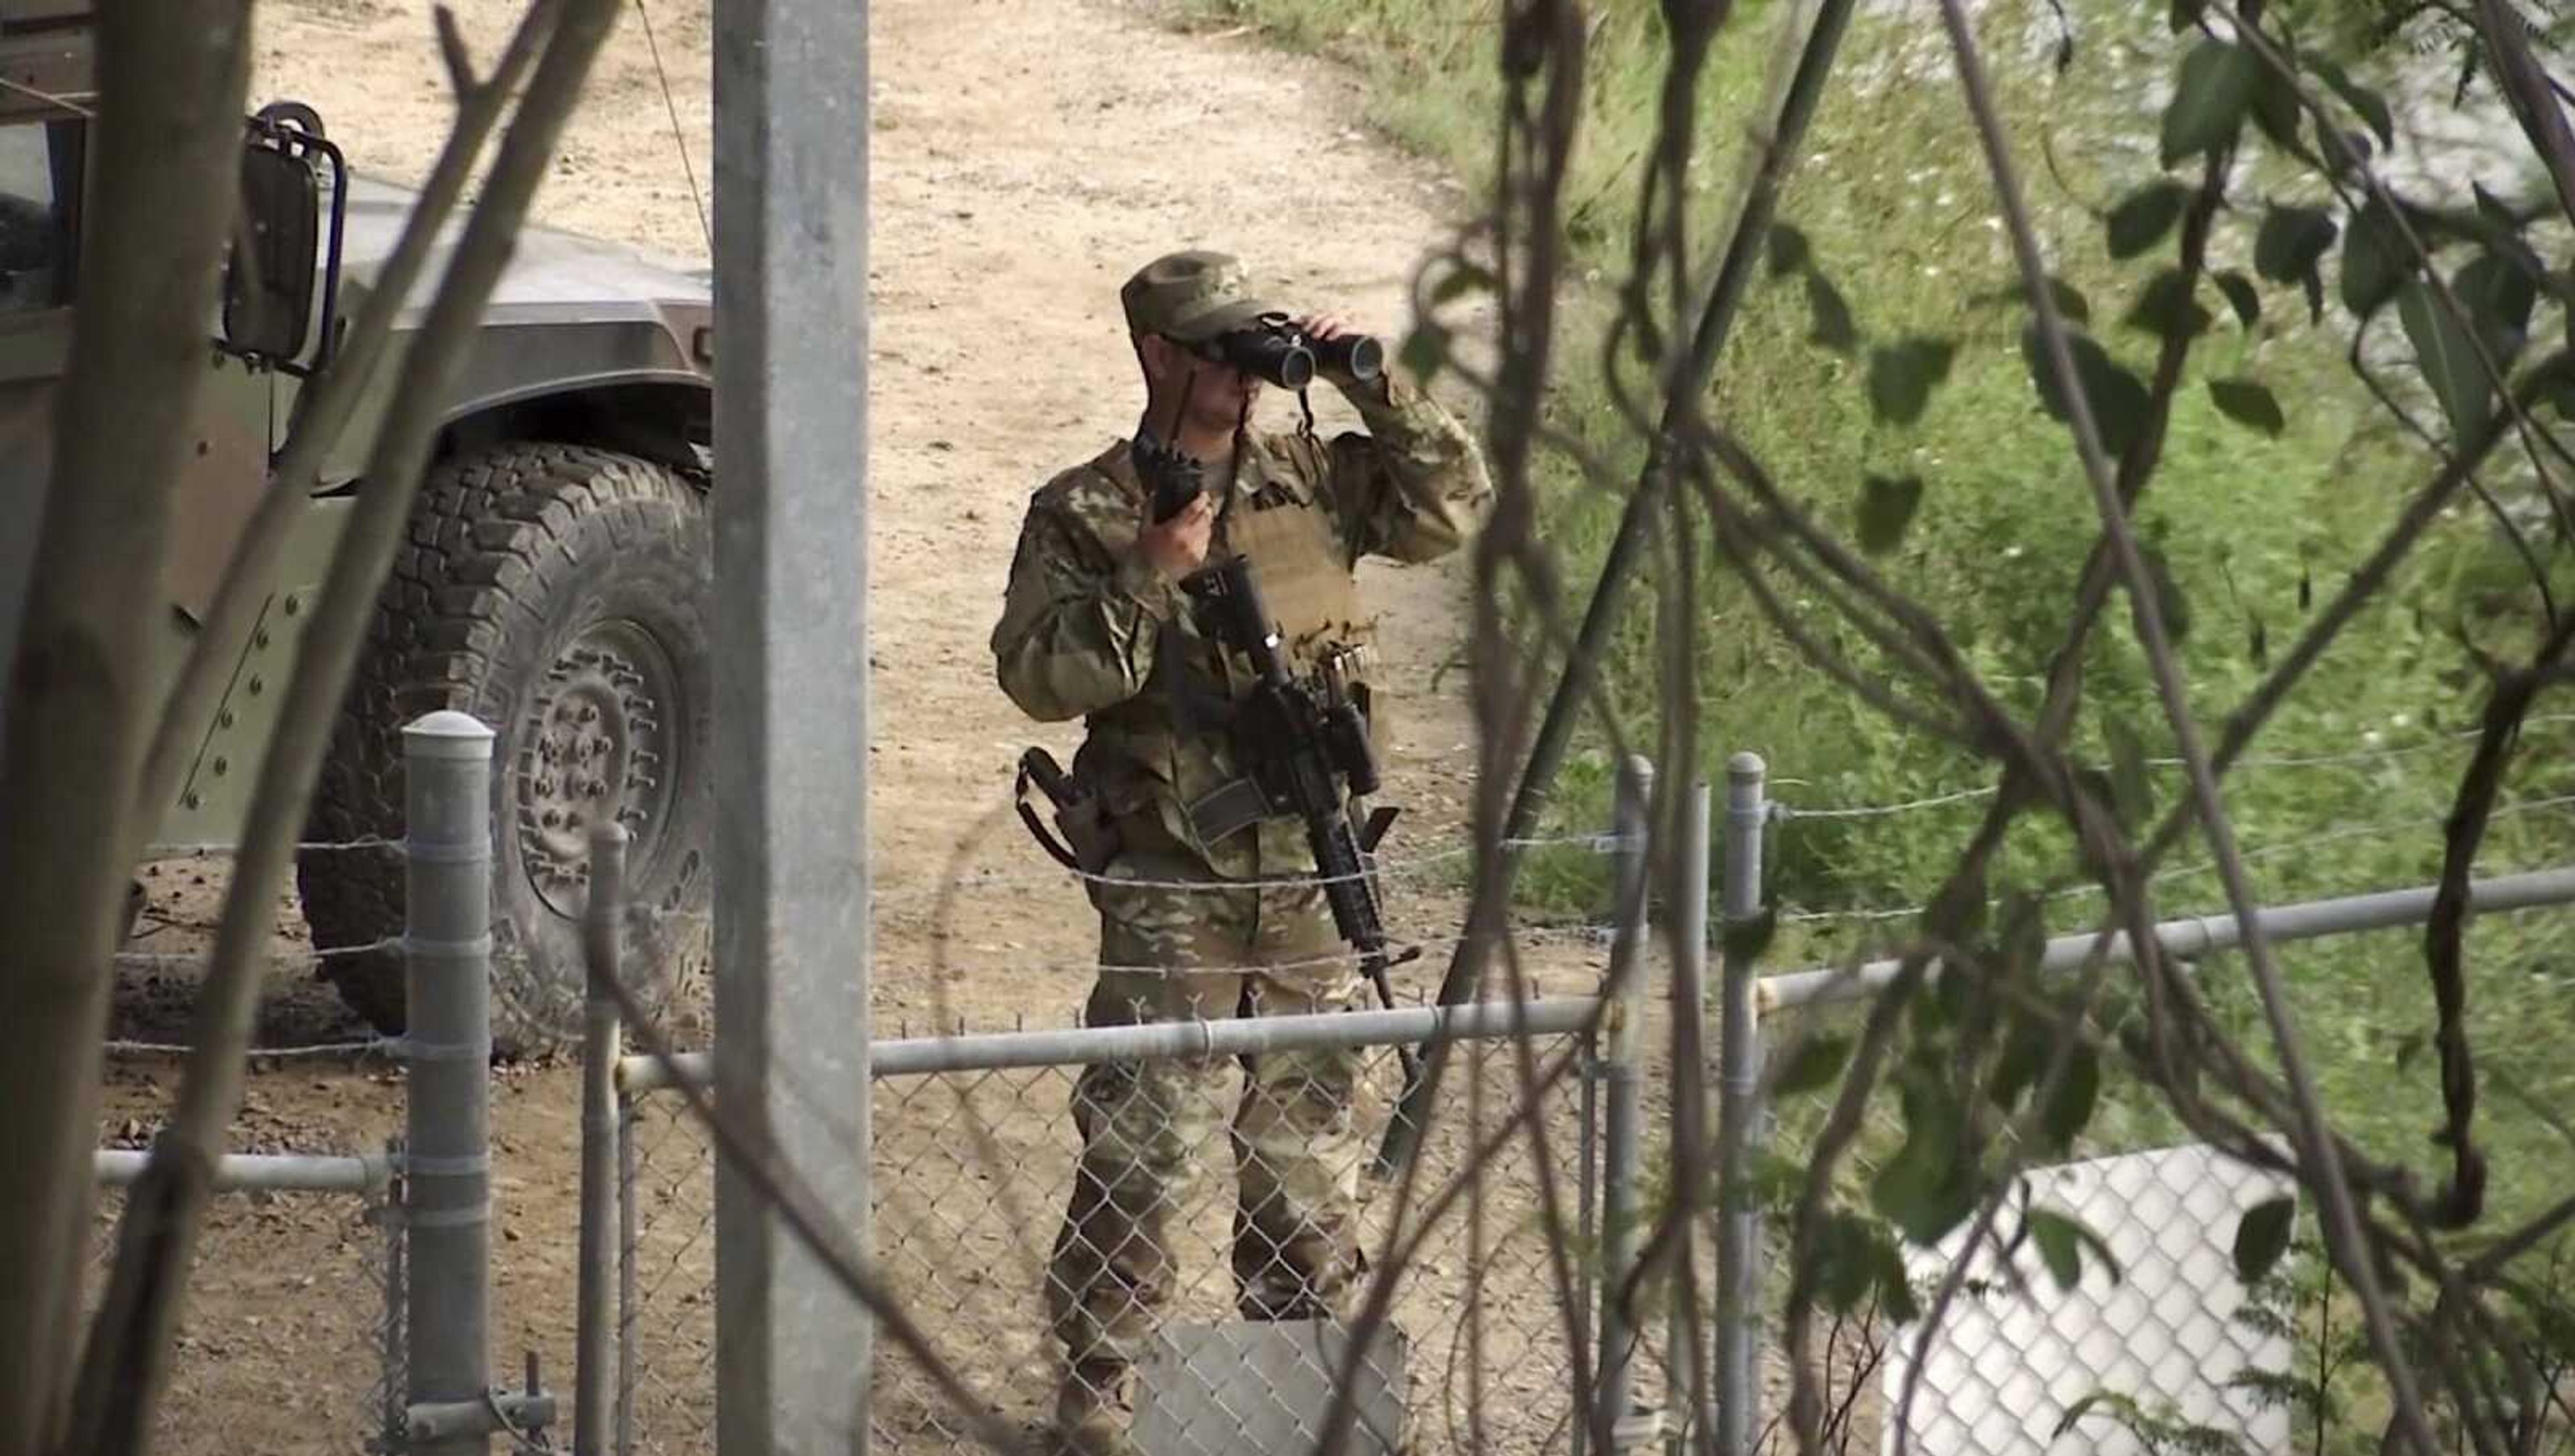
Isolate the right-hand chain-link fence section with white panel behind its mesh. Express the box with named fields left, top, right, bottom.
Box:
left=1743, top=751, right=2575, bottom=1456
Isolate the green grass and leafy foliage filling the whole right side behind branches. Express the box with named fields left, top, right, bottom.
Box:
left=1187, top=0, right=2575, bottom=1440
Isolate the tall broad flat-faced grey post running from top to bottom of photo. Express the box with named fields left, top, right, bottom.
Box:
left=713, top=0, right=870, bottom=1456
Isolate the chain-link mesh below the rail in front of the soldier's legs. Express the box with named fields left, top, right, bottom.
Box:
left=620, top=1013, right=1597, bottom=1453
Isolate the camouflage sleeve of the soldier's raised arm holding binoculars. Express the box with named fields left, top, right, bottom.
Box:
left=1324, top=375, right=1493, bottom=561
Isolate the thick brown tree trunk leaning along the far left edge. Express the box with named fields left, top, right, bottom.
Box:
left=0, top=0, right=249, bottom=1451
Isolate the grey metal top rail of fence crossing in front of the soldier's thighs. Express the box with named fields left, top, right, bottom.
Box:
left=618, top=995, right=1601, bottom=1096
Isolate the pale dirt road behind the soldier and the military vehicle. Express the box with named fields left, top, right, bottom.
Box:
left=105, top=0, right=1589, bottom=1451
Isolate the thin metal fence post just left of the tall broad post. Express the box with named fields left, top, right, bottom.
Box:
left=571, top=821, right=628, bottom=1456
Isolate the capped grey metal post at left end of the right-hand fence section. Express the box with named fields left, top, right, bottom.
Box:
left=1717, top=753, right=1769, bottom=1456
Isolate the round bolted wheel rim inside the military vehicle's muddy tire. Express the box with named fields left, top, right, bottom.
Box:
left=518, top=620, right=683, bottom=918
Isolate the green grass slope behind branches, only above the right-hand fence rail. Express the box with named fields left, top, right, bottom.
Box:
left=1174, top=0, right=2575, bottom=920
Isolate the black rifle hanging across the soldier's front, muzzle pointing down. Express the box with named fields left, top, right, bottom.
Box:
left=1187, top=556, right=1422, bottom=1126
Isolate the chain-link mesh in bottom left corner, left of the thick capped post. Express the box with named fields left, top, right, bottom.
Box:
left=82, top=1160, right=407, bottom=1456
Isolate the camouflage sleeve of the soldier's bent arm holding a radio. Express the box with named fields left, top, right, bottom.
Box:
left=991, top=473, right=1177, bottom=723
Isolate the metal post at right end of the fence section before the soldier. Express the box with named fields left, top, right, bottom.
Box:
left=1594, top=759, right=1653, bottom=1456
